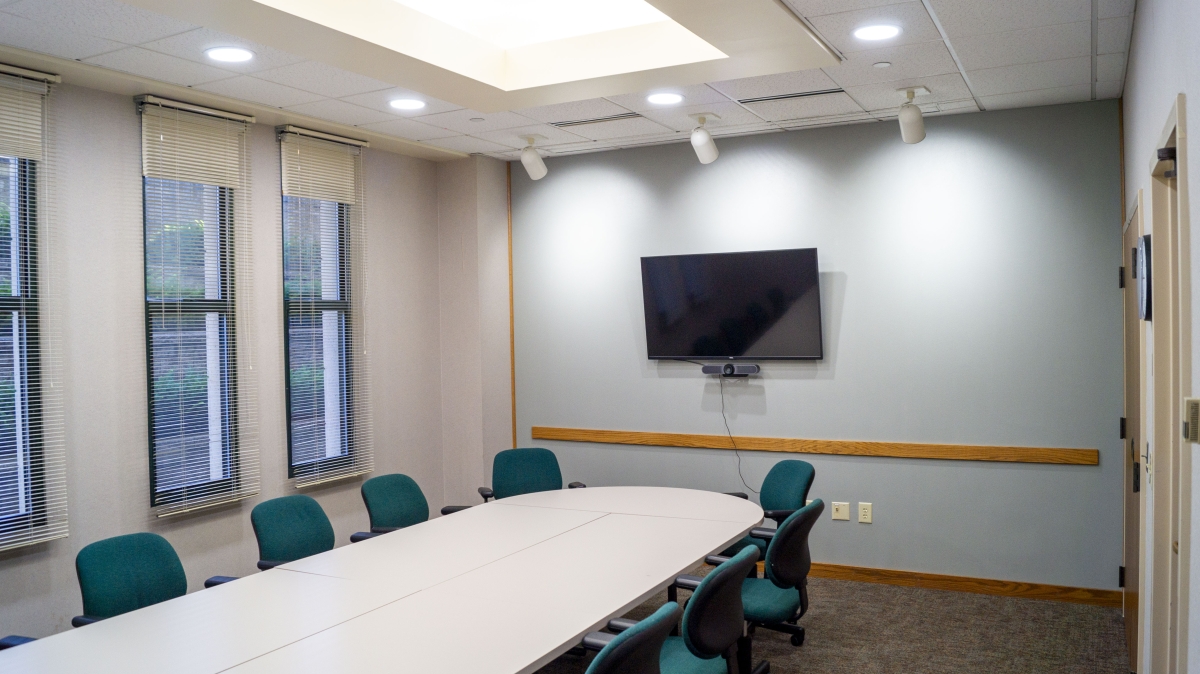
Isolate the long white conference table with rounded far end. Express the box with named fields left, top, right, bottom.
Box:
left=0, top=487, right=763, bottom=674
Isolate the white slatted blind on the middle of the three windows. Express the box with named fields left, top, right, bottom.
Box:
left=139, top=100, right=259, bottom=517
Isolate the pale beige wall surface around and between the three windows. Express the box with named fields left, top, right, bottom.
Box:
left=0, top=86, right=444, bottom=637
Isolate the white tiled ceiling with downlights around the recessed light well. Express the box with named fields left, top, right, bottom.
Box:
left=0, top=0, right=1134, bottom=160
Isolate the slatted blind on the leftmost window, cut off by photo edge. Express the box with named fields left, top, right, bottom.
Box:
left=0, top=74, right=67, bottom=550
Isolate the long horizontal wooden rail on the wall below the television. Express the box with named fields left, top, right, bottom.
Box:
left=533, top=426, right=1100, bottom=465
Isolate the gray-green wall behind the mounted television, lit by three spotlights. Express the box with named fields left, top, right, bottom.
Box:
left=512, top=101, right=1122, bottom=589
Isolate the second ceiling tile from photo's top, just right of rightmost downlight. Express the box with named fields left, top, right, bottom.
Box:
left=954, top=20, right=1092, bottom=71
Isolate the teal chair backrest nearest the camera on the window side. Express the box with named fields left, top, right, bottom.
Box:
left=76, top=534, right=187, bottom=618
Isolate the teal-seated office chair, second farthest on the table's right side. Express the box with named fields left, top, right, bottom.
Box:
left=706, top=499, right=824, bottom=663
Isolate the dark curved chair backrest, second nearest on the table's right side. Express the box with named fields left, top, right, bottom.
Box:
left=683, top=546, right=758, bottom=660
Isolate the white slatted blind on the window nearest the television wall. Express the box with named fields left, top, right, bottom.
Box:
left=280, top=131, right=374, bottom=487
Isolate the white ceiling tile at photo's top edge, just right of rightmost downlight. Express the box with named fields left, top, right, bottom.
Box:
left=930, top=0, right=1092, bottom=38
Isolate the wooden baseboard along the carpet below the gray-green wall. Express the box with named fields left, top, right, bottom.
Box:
left=809, top=562, right=1122, bottom=608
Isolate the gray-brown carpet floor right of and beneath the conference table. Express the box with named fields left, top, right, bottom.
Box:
left=541, top=570, right=1129, bottom=674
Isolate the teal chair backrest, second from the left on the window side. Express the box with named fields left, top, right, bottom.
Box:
left=250, top=494, right=334, bottom=562
